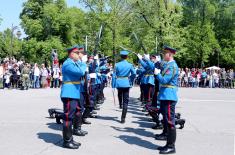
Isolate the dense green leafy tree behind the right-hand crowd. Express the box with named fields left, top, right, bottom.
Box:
left=181, top=0, right=220, bottom=67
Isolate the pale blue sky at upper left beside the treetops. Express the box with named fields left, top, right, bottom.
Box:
left=0, top=0, right=83, bottom=37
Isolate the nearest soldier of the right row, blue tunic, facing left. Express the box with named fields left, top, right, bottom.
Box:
left=154, top=46, right=179, bottom=154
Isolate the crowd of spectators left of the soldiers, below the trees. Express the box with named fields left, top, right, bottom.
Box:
left=0, top=57, right=62, bottom=89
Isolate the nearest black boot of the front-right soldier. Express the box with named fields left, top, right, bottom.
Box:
left=159, top=128, right=176, bottom=154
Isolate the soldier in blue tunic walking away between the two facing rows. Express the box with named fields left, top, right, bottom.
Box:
left=112, top=51, right=136, bottom=123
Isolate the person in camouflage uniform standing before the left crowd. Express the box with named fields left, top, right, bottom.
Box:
left=21, top=64, right=30, bottom=90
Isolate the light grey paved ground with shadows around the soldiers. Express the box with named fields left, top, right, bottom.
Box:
left=0, top=87, right=235, bottom=155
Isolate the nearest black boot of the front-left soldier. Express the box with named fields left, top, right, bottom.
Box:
left=63, top=127, right=81, bottom=149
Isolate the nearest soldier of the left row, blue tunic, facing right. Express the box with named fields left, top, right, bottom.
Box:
left=60, top=46, right=86, bottom=149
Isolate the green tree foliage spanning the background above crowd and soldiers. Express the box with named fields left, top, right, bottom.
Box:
left=0, top=0, right=235, bottom=67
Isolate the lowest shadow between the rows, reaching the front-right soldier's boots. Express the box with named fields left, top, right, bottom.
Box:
left=116, top=135, right=159, bottom=150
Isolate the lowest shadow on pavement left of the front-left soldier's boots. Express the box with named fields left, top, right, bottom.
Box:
left=37, top=132, right=63, bottom=146
